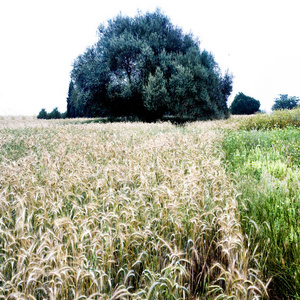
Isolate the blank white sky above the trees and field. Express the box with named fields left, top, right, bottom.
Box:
left=0, top=0, right=300, bottom=115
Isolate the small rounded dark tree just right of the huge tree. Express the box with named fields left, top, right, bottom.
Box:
left=229, top=93, right=260, bottom=115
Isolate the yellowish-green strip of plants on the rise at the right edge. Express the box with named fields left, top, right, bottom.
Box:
left=238, top=108, right=300, bottom=130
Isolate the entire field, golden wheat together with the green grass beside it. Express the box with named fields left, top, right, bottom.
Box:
left=0, top=111, right=300, bottom=300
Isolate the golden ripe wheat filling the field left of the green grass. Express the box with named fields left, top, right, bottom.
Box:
left=0, top=118, right=266, bottom=299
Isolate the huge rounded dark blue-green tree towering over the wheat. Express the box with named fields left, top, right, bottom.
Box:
left=68, top=10, right=232, bottom=120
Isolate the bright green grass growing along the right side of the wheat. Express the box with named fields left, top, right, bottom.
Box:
left=223, top=126, right=300, bottom=299
